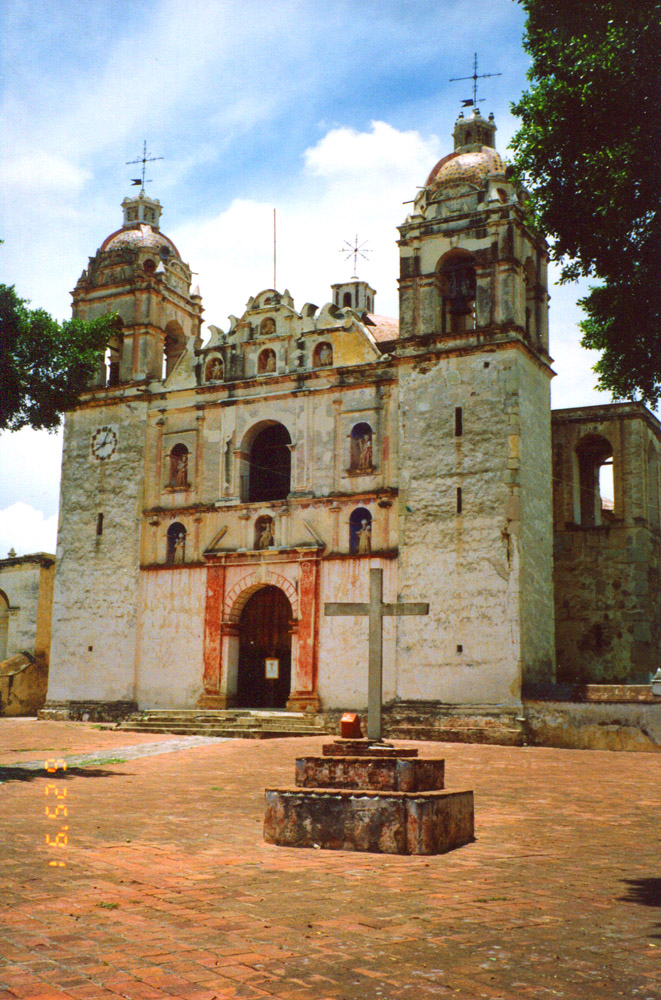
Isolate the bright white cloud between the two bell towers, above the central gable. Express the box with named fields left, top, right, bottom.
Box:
left=169, top=122, right=440, bottom=329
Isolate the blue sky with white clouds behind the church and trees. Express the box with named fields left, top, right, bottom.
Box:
left=0, top=0, right=605, bottom=557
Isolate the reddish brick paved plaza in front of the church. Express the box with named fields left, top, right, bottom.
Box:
left=0, top=719, right=661, bottom=1000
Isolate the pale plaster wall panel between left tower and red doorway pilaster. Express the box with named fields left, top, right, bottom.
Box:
left=136, top=567, right=207, bottom=709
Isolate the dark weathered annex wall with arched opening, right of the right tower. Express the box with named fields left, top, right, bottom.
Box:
left=553, top=403, right=661, bottom=684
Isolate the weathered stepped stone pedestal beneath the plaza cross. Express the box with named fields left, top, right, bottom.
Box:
left=264, top=740, right=474, bottom=854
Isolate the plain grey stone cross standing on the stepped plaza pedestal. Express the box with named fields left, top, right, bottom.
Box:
left=324, top=569, right=429, bottom=740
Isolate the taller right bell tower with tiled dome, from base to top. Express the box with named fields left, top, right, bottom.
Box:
left=398, top=107, right=554, bottom=707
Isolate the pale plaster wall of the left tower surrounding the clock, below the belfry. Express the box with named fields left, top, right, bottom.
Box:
left=48, top=398, right=145, bottom=701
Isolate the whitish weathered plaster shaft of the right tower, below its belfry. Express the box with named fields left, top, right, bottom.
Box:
left=398, top=349, right=552, bottom=704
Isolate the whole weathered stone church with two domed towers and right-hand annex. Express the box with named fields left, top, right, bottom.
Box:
left=43, top=110, right=661, bottom=728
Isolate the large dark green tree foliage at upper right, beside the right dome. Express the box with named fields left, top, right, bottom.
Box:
left=512, top=0, right=661, bottom=405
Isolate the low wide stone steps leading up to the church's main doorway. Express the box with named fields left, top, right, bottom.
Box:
left=118, top=709, right=326, bottom=740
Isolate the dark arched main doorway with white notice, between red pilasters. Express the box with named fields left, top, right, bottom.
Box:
left=236, top=586, right=292, bottom=708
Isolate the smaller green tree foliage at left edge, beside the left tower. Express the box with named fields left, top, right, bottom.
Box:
left=0, top=285, right=117, bottom=431
